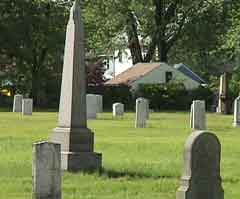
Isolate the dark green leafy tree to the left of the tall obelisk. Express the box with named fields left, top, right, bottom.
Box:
left=0, top=0, right=68, bottom=104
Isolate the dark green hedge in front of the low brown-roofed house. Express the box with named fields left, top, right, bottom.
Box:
left=136, top=84, right=214, bottom=110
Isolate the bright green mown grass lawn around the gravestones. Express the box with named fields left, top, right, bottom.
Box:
left=0, top=112, right=240, bottom=199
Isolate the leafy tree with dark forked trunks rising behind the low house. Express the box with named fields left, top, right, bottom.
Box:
left=82, top=0, right=223, bottom=64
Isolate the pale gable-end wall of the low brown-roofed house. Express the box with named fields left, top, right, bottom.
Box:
left=131, top=63, right=200, bottom=90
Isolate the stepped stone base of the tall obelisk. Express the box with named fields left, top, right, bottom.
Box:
left=50, top=127, right=102, bottom=171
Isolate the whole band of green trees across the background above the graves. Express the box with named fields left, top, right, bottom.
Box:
left=0, top=0, right=240, bottom=109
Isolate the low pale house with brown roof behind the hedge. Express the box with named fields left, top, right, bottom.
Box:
left=105, top=63, right=206, bottom=90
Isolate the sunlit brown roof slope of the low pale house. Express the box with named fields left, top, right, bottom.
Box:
left=105, top=63, right=164, bottom=85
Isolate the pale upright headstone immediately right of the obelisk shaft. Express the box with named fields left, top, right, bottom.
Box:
left=86, top=94, right=98, bottom=119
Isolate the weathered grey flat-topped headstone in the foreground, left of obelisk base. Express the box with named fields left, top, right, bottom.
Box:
left=33, top=142, right=61, bottom=199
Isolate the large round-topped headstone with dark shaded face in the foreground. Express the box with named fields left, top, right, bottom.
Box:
left=176, top=131, right=224, bottom=199
